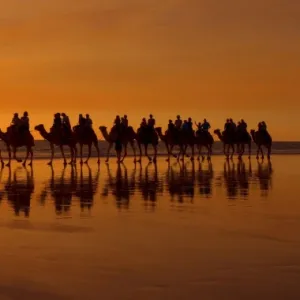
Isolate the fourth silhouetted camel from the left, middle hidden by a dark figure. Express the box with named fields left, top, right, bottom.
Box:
left=99, top=126, right=137, bottom=162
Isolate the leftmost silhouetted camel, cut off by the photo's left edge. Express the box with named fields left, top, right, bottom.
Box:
left=0, top=127, right=34, bottom=166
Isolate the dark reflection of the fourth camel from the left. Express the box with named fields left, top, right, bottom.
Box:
left=102, top=163, right=135, bottom=209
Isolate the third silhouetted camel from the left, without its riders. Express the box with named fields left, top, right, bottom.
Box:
left=73, top=125, right=100, bottom=164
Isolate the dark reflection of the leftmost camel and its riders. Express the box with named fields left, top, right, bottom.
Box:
left=5, top=167, right=34, bottom=217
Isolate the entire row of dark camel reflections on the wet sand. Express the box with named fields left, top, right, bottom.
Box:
left=0, top=160, right=273, bottom=217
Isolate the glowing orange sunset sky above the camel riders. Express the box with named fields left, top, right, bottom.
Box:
left=0, top=0, right=300, bottom=140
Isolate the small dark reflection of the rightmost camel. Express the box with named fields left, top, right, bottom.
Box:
left=255, top=161, right=273, bottom=196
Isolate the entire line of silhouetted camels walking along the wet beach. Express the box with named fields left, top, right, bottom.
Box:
left=0, top=114, right=272, bottom=166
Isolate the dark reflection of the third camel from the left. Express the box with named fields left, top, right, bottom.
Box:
left=75, top=165, right=100, bottom=211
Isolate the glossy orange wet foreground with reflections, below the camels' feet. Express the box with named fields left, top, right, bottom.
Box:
left=0, top=156, right=300, bottom=299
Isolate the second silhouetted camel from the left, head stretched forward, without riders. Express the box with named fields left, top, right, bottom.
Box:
left=34, top=124, right=77, bottom=166
